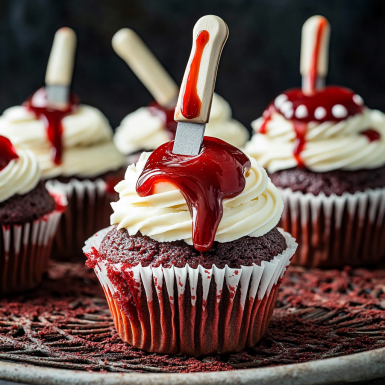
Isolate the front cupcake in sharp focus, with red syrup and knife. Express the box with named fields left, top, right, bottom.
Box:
left=84, top=16, right=296, bottom=356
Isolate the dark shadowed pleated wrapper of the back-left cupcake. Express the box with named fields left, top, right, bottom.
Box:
left=46, top=178, right=118, bottom=260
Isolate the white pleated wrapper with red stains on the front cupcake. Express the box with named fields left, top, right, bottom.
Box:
left=83, top=228, right=297, bottom=356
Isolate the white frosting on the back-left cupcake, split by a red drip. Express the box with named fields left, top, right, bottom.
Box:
left=0, top=105, right=124, bottom=179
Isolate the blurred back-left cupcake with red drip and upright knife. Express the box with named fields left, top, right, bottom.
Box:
left=0, top=28, right=125, bottom=259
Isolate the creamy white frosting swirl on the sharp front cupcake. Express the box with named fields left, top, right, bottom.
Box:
left=111, top=153, right=283, bottom=245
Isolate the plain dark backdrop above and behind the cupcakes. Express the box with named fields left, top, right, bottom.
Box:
left=0, top=0, right=385, bottom=132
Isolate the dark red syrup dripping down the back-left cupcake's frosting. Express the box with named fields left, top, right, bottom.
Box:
left=24, top=87, right=79, bottom=164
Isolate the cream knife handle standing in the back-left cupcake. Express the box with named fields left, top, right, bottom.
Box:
left=45, top=27, right=76, bottom=86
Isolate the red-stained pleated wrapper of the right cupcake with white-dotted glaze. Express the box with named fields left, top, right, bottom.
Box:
left=280, top=188, right=385, bottom=267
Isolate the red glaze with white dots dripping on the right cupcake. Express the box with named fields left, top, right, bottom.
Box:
left=259, top=86, right=363, bottom=166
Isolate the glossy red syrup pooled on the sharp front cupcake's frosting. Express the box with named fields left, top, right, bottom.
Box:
left=136, top=136, right=251, bottom=252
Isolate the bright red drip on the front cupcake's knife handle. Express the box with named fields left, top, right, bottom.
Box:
left=181, top=30, right=210, bottom=119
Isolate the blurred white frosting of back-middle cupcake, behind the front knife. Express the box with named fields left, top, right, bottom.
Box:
left=114, top=94, right=249, bottom=155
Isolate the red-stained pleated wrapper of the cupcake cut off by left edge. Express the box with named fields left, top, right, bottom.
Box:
left=0, top=190, right=67, bottom=296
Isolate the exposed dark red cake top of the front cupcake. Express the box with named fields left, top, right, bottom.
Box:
left=99, top=227, right=287, bottom=269
